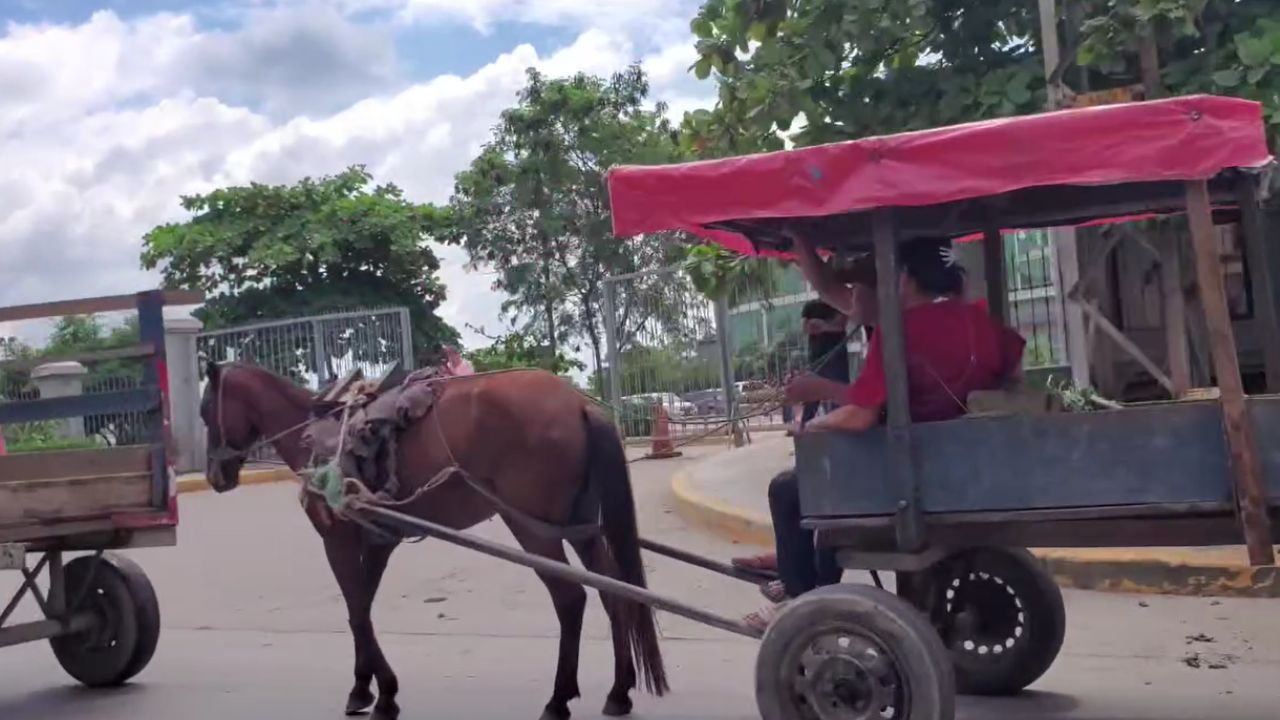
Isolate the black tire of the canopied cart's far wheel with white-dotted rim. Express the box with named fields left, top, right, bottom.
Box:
left=928, top=547, right=1066, bottom=696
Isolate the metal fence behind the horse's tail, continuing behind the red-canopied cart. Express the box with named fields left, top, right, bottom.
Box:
left=604, top=231, right=1066, bottom=439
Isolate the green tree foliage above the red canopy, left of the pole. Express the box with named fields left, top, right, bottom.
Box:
left=685, top=0, right=1044, bottom=155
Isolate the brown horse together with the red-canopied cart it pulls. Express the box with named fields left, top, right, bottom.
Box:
left=194, top=97, right=1280, bottom=720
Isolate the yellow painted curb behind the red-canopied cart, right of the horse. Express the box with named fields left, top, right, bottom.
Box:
left=671, top=470, right=1280, bottom=598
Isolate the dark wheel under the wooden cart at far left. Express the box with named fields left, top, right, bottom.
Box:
left=50, top=553, right=160, bottom=688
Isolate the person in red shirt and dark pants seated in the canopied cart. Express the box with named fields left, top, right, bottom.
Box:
left=746, top=240, right=1025, bottom=626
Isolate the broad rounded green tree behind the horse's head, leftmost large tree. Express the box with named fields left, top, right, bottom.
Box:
left=142, top=165, right=458, bottom=370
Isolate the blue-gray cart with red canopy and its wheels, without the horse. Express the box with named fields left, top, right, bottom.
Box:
left=609, top=97, right=1280, bottom=720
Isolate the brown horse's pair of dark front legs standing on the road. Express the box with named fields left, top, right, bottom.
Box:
left=324, top=523, right=399, bottom=720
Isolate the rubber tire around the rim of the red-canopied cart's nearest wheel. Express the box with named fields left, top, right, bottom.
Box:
left=755, top=584, right=956, bottom=720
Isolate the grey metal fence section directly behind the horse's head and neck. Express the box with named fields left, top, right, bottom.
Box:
left=196, top=307, right=413, bottom=389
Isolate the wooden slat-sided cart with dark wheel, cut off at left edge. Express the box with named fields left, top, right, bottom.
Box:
left=0, top=291, right=201, bottom=687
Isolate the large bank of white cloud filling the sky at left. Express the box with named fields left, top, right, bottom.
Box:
left=0, top=7, right=711, bottom=351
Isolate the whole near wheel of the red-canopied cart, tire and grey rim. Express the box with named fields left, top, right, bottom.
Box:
left=755, top=584, right=955, bottom=720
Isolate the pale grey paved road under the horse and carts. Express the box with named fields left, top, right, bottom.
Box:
left=0, top=448, right=1280, bottom=720
